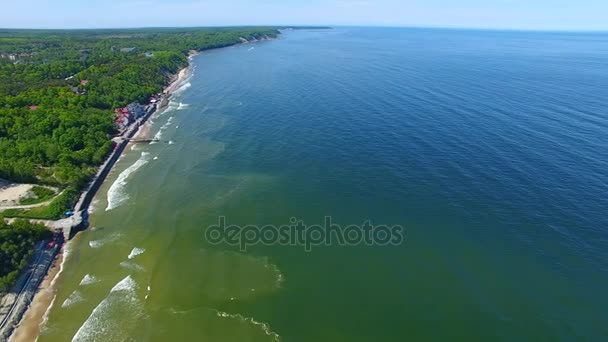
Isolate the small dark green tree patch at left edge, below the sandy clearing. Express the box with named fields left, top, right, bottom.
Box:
left=0, top=215, right=52, bottom=292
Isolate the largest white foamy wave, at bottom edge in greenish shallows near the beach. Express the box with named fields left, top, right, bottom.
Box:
left=72, top=276, right=144, bottom=342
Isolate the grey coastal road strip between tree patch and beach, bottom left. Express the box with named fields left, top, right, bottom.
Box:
left=0, top=243, right=60, bottom=341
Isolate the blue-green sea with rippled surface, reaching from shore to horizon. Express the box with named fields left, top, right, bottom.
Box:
left=38, top=27, right=608, bottom=342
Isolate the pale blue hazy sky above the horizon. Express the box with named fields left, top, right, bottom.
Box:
left=0, top=0, right=608, bottom=31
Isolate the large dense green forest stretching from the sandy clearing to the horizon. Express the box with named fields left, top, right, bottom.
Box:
left=0, top=27, right=278, bottom=204
